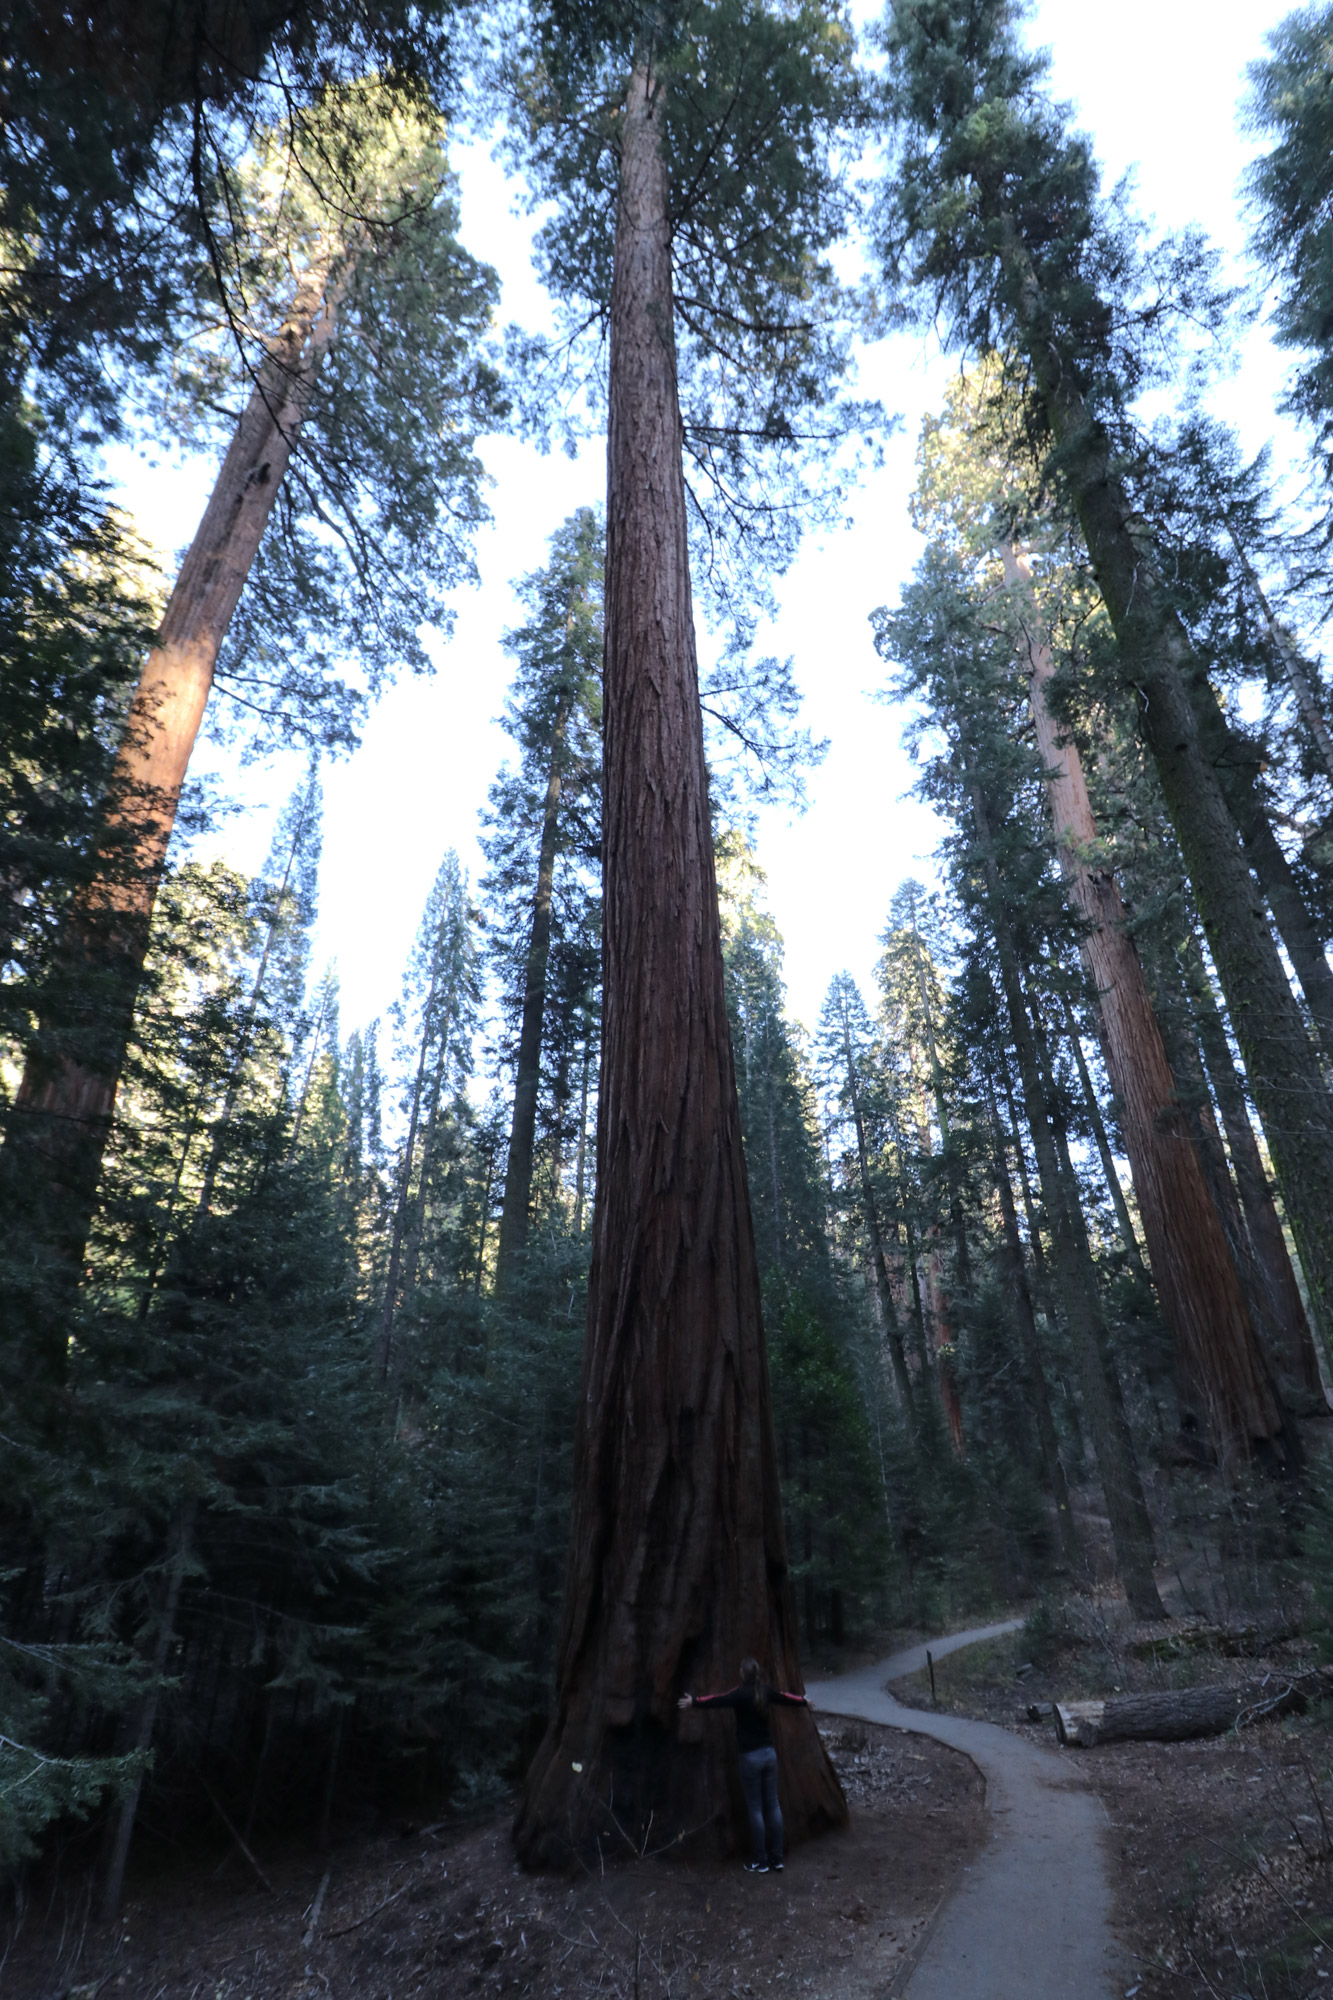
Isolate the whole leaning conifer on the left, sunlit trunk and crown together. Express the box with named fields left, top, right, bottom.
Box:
left=0, top=84, right=504, bottom=1372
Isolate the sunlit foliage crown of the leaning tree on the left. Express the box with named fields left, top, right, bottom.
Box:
left=157, top=78, right=506, bottom=748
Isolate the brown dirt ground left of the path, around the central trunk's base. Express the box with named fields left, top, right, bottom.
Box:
left=0, top=1722, right=983, bottom=2000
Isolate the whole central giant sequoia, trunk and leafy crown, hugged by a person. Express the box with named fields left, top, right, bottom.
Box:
left=500, top=0, right=849, bottom=1862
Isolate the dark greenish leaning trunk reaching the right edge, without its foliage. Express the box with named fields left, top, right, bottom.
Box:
left=1000, top=230, right=1333, bottom=1306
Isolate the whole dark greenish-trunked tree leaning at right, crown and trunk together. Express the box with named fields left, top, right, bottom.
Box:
left=868, top=0, right=1333, bottom=1336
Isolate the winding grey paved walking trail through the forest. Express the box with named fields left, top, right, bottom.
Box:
left=809, top=1618, right=1112, bottom=2000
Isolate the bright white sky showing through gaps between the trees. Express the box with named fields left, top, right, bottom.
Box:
left=108, top=0, right=1291, bottom=1034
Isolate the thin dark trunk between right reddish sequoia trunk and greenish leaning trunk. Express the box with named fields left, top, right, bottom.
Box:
left=1185, top=934, right=1323, bottom=1398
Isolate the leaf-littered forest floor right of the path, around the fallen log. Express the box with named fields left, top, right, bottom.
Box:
left=891, top=1606, right=1333, bottom=2000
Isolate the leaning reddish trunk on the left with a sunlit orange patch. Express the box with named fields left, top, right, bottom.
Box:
left=0, top=246, right=336, bottom=1344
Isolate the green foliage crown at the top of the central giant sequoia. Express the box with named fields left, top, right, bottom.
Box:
left=496, top=0, right=881, bottom=628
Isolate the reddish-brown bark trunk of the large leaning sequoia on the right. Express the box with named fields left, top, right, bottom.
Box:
left=1003, top=542, right=1283, bottom=1460
